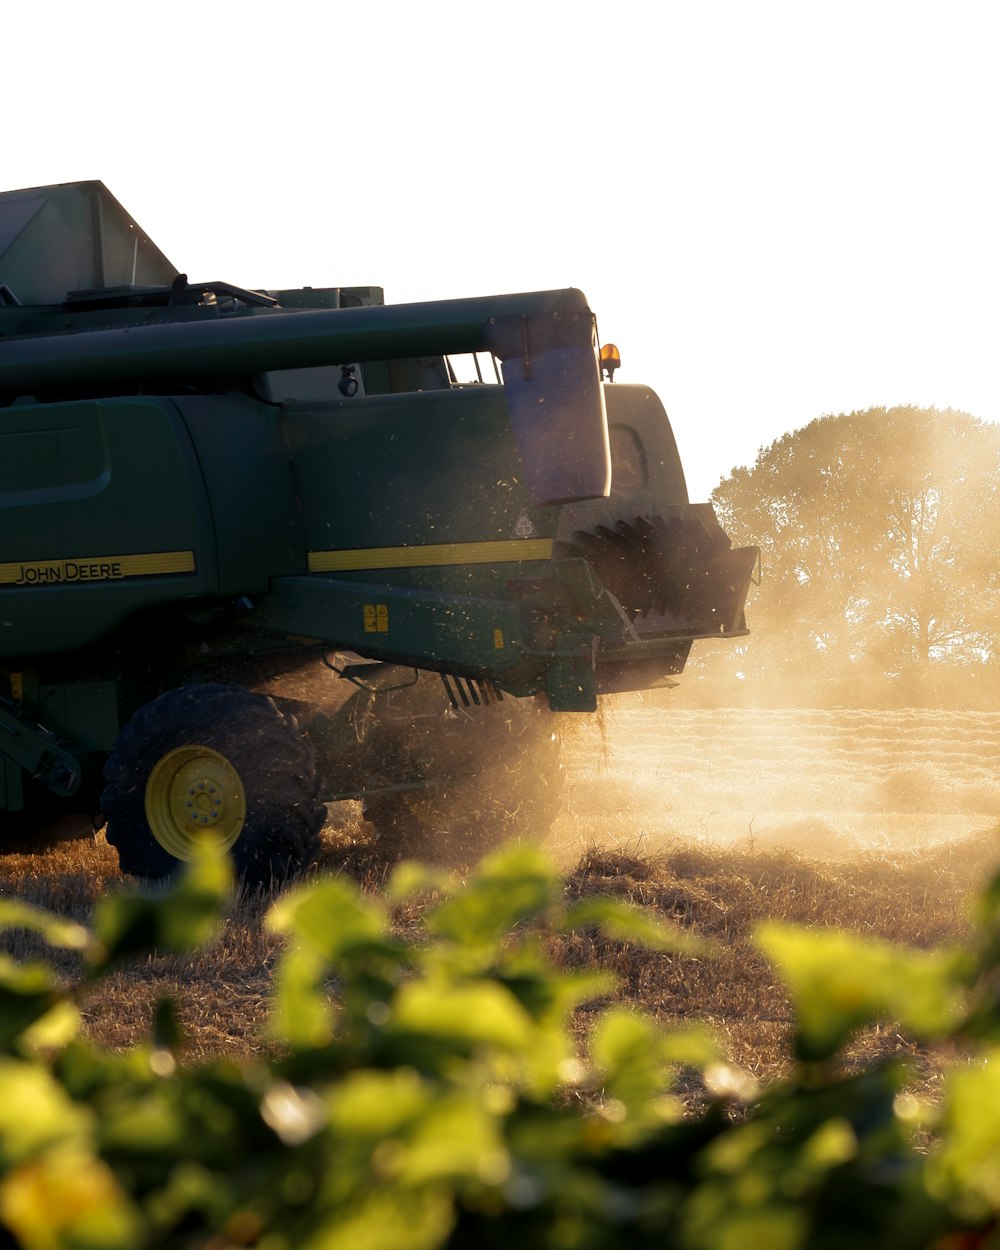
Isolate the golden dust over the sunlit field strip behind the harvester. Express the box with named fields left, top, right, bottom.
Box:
left=549, top=695, right=1000, bottom=863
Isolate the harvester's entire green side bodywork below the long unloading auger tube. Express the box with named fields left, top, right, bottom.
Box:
left=0, top=386, right=740, bottom=689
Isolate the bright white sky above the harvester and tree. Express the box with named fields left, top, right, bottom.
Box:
left=0, top=0, right=1000, bottom=499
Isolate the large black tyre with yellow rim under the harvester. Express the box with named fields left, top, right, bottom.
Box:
left=101, top=684, right=326, bottom=885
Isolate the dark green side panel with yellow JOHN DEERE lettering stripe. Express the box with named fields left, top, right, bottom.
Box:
left=0, top=399, right=219, bottom=660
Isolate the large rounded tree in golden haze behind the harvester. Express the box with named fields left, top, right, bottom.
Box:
left=713, top=408, right=1000, bottom=681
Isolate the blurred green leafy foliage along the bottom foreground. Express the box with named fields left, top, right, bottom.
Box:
left=0, top=848, right=1000, bottom=1250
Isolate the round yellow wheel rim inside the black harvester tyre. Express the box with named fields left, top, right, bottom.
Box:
left=146, top=746, right=246, bottom=863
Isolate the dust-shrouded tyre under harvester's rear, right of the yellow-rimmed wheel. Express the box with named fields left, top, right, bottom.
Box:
left=355, top=676, right=564, bottom=868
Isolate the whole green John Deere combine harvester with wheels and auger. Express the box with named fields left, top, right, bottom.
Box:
left=0, top=183, right=756, bottom=881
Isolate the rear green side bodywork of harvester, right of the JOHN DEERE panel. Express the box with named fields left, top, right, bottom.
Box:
left=248, top=386, right=735, bottom=709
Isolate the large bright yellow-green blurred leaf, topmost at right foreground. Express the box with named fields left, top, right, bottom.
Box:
left=755, top=921, right=964, bottom=1059
